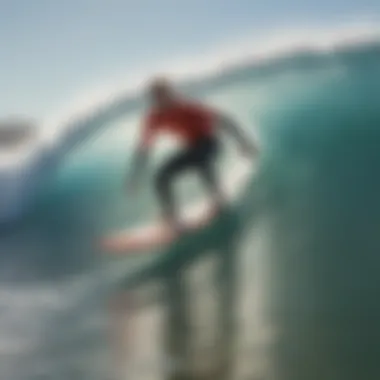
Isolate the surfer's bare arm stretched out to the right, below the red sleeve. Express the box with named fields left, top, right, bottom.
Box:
left=217, top=113, right=259, bottom=156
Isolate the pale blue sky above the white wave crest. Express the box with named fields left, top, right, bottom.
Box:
left=0, top=0, right=380, bottom=117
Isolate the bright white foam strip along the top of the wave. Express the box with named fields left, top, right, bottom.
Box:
left=43, top=20, right=380, bottom=140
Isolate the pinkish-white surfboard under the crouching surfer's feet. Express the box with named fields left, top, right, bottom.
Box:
left=101, top=161, right=253, bottom=254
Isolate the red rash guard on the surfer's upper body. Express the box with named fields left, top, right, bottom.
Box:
left=142, top=102, right=216, bottom=148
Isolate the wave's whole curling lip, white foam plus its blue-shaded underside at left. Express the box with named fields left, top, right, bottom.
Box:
left=0, top=22, right=380, bottom=221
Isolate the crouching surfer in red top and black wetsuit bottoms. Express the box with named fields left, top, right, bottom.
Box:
left=128, top=78, right=257, bottom=232
